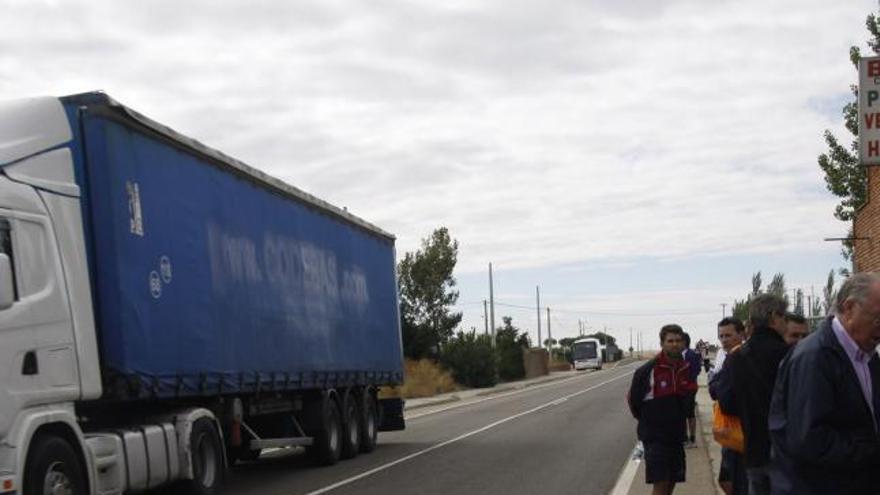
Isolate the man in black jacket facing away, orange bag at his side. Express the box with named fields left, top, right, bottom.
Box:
left=718, top=294, right=788, bottom=495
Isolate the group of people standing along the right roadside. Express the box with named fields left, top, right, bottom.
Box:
left=627, top=273, right=880, bottom=495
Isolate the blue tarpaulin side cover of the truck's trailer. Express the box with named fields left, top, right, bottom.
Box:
left=63, top=94, right=402, bottom=398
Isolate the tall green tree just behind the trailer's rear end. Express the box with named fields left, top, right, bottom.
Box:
left=397, top=227, right=462, bottom=359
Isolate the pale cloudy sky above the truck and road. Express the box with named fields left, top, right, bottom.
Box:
left=0, top=0, right=878, bottom=348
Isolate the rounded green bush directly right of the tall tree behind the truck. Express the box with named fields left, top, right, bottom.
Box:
left=440, top=331, right=498, bottom=388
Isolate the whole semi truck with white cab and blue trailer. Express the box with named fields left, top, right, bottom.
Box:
left=0, top=93, right=404, bottom=495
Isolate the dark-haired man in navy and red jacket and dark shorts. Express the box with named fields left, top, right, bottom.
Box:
left=627, top=325, right=696, bottom=495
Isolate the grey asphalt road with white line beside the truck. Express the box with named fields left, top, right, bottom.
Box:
left=202, top=365, right=635, bottom=495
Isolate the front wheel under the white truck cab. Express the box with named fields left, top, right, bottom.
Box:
left=23, top=435, right=86, bottom=495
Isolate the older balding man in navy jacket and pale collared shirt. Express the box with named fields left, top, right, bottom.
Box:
left=770, top=273, right=880, bottom=495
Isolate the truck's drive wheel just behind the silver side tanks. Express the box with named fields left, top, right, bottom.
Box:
left=180, top=418, right=224, bottom=495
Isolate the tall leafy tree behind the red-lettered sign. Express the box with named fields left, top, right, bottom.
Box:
left=818, top=14, right=880, bottom=260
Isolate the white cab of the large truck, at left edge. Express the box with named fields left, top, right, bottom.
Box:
left=0, top=98, right=101, bottom=493
